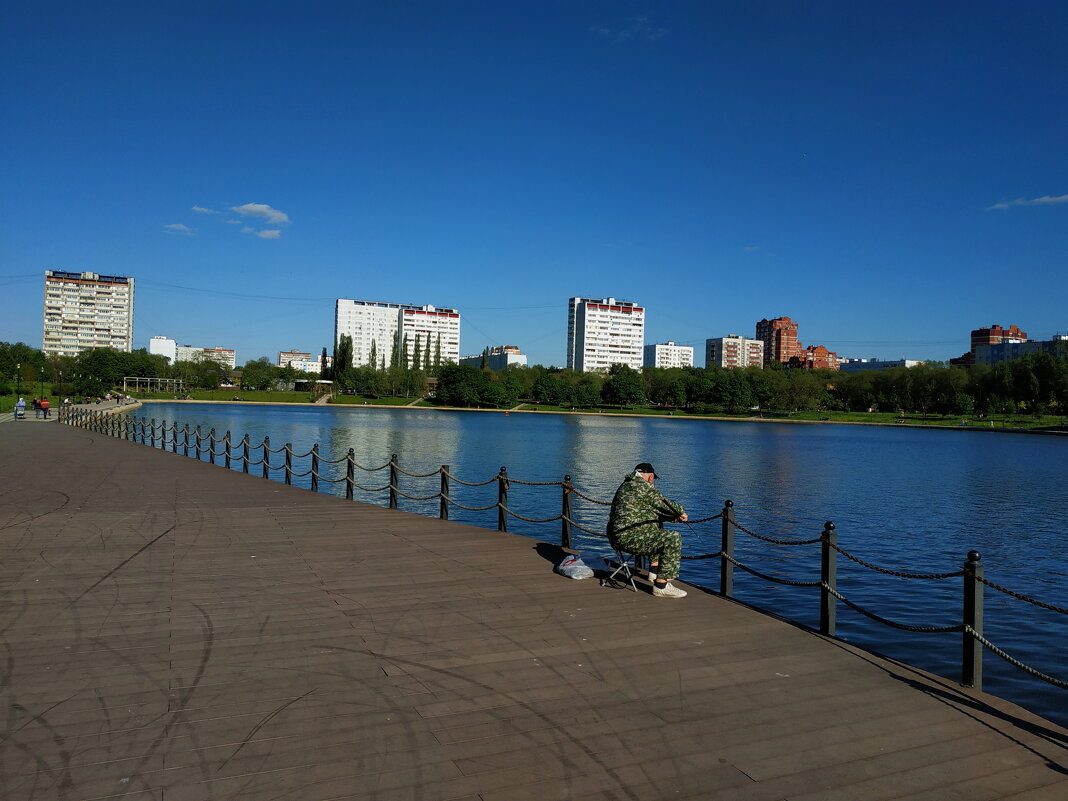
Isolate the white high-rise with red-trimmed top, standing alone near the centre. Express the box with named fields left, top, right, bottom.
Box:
left=567, top=298, right=645, bottom=373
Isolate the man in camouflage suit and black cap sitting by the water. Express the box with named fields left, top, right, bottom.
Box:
left=608, top=461, right=687, bottom=598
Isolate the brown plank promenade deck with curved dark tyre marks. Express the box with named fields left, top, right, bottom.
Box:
left=6, top=422, right=1068, bottom=801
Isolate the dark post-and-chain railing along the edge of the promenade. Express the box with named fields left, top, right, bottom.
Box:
left=58, top=407, right=1068, bottom=689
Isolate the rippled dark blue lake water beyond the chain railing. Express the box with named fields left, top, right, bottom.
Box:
left=137, top=403, right=1068, bottom=724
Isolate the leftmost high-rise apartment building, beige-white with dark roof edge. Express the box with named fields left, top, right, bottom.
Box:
left=41, top=270, right=134, bottom=356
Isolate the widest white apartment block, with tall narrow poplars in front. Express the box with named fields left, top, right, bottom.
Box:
left=334, top=298, right=460, bottom=367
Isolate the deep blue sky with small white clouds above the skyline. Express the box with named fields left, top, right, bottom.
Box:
left=0, top=0, right=1068, bottom=364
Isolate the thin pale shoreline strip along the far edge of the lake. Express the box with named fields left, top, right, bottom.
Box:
left=137, top=398, right=1068, bottom=437
